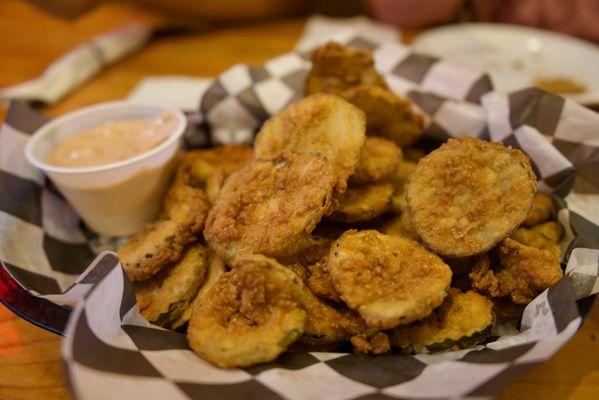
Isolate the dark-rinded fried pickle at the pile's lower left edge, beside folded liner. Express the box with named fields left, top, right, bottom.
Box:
left=133, top=245, right=208, bottom=328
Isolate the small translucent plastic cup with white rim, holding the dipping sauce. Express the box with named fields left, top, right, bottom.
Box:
left=25, top=101, right=187, bottom=236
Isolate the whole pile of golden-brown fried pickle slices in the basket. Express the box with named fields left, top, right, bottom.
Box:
left=119, top=43, right=563, bottom=368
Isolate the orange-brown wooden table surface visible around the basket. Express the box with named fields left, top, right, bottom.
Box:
left=0, top=0, right=599, bottom=400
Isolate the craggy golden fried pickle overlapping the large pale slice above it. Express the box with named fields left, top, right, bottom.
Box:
left=204, top=153, right=335, bottom=263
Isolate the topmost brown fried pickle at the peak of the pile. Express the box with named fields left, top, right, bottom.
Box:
left=304, top=42, right=387, bottom=96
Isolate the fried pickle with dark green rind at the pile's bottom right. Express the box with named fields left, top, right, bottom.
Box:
left=392, top=288, right=495, bottom=353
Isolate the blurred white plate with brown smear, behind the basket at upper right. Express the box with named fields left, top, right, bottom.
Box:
left=412, top=24, right=599, bottom=104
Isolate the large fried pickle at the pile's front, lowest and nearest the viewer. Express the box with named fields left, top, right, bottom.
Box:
left=187, top=255, right=306, bottom=368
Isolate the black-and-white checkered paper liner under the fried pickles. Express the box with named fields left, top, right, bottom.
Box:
left=0, top=33, right=599, bottom=399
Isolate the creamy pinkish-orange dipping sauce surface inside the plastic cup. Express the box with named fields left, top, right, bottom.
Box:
left=46, top=113, right=179, bottom=167
